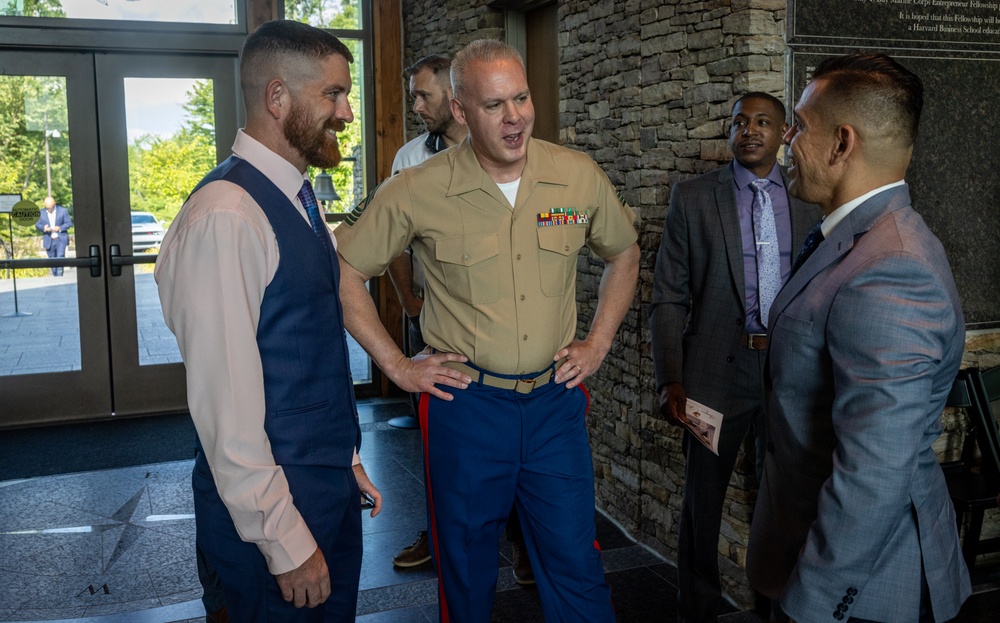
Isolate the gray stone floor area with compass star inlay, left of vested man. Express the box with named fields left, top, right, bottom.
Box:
left=0, top=461, right=201, bottom=621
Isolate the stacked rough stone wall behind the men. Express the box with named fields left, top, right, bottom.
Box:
left=403, top=0, right=998, bottom=606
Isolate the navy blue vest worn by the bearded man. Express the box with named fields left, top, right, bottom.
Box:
left=192, top=156, right=361, bottom=467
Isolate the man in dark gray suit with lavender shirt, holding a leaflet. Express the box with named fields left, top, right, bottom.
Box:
left=650, top=93, right=820, bottom=622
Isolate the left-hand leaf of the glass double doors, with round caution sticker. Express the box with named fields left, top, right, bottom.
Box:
left=0, top=52, right=113, bottom=426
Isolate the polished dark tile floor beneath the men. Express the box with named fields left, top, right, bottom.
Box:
left=0, top=400, right=1000, bottom=623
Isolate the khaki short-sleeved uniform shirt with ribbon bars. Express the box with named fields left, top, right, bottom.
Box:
left=336, top=138, right=637, bottom=374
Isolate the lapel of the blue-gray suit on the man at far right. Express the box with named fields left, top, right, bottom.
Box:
left=771, top=184, right=910, bottom=319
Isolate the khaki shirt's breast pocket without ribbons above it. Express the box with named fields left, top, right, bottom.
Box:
left=434, top=234, right=500, bottom=305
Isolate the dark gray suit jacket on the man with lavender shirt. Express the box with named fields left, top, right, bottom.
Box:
left=649, top=164, right=820, bottom=420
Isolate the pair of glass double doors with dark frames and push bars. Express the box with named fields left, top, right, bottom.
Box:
left=0, top=51, right=240, bottom=428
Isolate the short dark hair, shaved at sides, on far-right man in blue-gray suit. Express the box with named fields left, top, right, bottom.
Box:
left=812, top=53, right=924, bottom=147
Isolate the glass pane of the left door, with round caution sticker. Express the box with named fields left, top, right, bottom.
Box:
left=0, top=73, right=81, bottom=376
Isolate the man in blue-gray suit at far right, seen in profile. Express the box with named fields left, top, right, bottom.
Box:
left=747, top=54, right=971, bottom=623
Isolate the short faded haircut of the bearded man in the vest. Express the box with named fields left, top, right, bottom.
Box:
left=240, top=19, right=354, bottom=105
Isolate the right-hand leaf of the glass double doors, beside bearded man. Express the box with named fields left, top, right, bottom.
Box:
left=95, top=53, right=242, bottom=415
